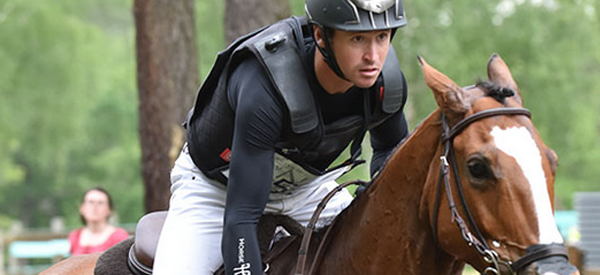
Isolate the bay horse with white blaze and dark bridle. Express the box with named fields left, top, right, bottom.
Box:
left=42, top=54, right=579, bottom=275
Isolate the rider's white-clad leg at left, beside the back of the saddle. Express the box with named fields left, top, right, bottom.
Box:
left=153, top=149, right=226, bottom=275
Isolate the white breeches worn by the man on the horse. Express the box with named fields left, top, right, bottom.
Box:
left=153, top=148, right=352, bottom=275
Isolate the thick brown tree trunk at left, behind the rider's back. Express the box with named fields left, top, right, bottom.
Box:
left=134, top=0, right=198, bottom=212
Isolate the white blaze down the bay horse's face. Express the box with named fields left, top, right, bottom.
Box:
left=490, top=126, right=563, bottom=244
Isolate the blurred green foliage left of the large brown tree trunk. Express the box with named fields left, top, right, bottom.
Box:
left=0, top=1, right=143, bottom=226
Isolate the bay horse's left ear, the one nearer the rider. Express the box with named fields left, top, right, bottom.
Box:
left=418, top=56, right=470, bottom=117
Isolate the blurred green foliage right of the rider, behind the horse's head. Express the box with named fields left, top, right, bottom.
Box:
left=394, top=0, right=600, bottom=207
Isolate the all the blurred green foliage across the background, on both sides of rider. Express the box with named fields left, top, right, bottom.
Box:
left=0, top=0, right=600, bottom=231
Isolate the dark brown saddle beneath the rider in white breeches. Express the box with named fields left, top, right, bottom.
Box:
left=127, top=211, right=304, bottom=275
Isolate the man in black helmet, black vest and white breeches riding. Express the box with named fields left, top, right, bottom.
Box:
left=153, top=0, right=408, bottom=275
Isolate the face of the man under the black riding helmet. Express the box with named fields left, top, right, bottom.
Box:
left=331, top=30, right=391, bottom=88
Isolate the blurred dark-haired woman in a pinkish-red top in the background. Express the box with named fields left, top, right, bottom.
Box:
left=69, top=187, right=129, bottom=255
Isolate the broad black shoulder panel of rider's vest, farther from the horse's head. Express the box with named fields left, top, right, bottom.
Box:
left=252, top=19, right=319, bottom=134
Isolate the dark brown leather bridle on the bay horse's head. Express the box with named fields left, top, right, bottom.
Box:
left=433, top=108, right=568, bottom=274
